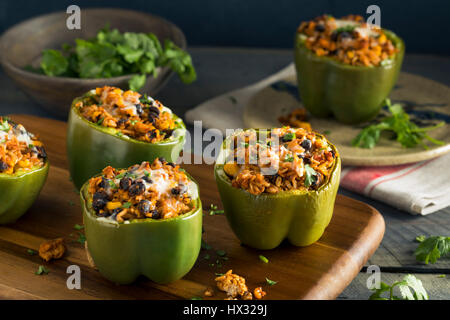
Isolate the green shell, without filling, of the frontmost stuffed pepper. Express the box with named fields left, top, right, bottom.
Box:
left=80, top=171, right=202, bottom=284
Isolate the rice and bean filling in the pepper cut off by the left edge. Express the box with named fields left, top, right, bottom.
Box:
left=0, top=117, right=47, bottom=174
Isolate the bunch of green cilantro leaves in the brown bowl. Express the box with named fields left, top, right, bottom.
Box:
left=34, top=27, right=197, bottom=91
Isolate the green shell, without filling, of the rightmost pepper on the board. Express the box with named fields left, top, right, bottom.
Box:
left=214, top=130, right=341, bottom=249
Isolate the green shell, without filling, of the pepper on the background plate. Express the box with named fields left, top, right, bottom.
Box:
left=294, top=30, right=405, bottom=124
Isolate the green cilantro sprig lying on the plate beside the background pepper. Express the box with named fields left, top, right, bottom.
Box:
left=352, top=99, right=445, bottom=149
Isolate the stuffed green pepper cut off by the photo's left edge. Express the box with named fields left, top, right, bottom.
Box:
left=0, top=117, right=49, bottom=224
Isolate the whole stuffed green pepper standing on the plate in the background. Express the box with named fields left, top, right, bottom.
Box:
left=294, top=16, right=405, bottom=124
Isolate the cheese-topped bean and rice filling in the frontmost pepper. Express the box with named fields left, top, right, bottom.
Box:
left=88, top=158, right=195, bottom=222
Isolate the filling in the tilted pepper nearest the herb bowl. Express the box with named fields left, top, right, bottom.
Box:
left=75, top=86, right=180, bottom=143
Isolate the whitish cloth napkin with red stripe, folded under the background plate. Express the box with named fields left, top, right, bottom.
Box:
left=186, top=64, right=450, bottom=215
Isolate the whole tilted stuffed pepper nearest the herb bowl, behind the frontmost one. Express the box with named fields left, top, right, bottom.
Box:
left=67, top=87, right=186, bottom=189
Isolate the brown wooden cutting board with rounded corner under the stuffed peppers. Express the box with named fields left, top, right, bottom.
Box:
left=0, top=115, right=384, bottom=299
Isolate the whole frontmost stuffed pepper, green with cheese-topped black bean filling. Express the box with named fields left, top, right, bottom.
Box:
left=80, top=159, right=202, bottom=284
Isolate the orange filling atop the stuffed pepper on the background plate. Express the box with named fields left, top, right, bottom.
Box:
left=297, top=15, right=398, bottom=66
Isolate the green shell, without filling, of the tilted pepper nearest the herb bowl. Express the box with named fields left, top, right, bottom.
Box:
left=67, top=97, right=186, bottom=190
